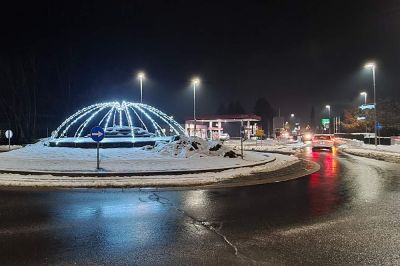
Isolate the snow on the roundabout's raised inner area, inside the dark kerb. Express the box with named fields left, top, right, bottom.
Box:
left=0, top=138, right=274, bottom=173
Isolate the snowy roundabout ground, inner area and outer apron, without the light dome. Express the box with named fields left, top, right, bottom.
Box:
left=0, top=138, right=319, bottom=188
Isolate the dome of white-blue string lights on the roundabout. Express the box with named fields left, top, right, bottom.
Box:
left=49, top=101, right=186, bottom=148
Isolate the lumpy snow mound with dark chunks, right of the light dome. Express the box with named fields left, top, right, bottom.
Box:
left=154, top=136, right=237, bottom=158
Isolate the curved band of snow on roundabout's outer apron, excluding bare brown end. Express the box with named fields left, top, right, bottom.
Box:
left=0, top=154, right=300, bottom=187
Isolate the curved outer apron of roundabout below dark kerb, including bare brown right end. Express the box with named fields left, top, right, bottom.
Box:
left=0, top=155, right=319, bottom=188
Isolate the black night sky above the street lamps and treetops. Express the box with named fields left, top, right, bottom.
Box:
left=0, top=0, right=400, bottom=123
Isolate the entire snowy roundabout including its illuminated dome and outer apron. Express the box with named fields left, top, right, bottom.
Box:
left=0, top=101, right=318, bottom=187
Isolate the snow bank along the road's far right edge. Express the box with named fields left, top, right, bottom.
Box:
left=337, top=139, right=400, bottom=163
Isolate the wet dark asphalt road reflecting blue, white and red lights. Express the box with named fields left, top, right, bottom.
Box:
left=0, top=147, right=400, bottom=265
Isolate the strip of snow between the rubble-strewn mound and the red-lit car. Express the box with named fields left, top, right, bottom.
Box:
left=225, top=139, right=308, bottom=154
